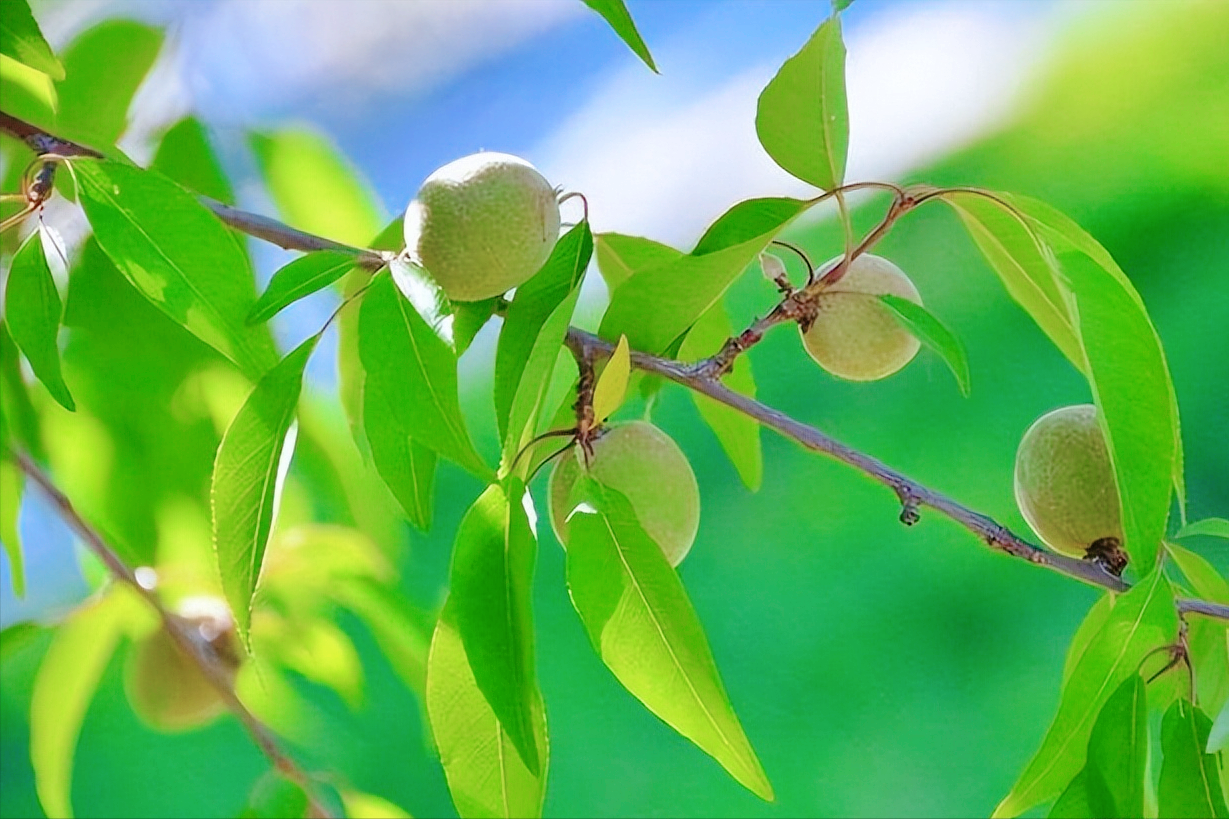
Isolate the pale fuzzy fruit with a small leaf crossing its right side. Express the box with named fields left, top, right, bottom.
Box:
left=803, top=253, right=922, bottom=381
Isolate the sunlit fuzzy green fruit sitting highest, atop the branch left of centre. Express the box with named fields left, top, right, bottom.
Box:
left=404, top=151, right=559, bottom=301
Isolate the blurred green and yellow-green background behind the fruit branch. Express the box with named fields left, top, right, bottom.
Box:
left=0, top=0, right=1229, bottom=817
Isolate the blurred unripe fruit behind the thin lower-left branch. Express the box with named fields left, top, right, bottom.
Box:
left=124, top=596, right=240, bottom=732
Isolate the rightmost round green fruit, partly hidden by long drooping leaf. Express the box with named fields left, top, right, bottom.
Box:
left=1015, top=403, right=1122, bottom=557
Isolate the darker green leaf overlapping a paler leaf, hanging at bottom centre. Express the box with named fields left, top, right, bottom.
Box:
left=449, top=478, right=542, bottom=776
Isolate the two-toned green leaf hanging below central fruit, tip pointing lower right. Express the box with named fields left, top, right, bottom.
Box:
left=568, top=481, right=773, bottom=801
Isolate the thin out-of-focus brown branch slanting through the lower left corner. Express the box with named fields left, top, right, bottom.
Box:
left=14, top=451, right=331, bottom=817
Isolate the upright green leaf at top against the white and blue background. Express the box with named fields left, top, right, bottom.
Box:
left=756, top=15, right=849, bottom=191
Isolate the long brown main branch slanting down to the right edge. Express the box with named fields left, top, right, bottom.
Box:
left=0, top=116, right=1229, bottom=620
